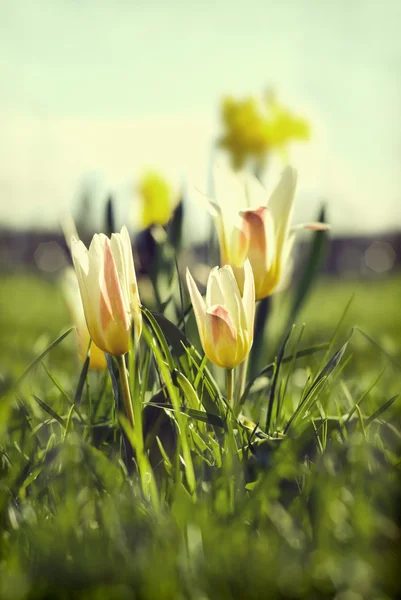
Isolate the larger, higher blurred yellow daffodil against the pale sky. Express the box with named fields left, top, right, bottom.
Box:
left=220, top=93, right=310, bottom=169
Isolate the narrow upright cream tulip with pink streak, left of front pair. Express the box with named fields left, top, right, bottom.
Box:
left=71, top=227, right=142, bottom=356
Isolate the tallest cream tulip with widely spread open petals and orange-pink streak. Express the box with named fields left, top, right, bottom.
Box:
left=203, top=166, right=328, bottom=300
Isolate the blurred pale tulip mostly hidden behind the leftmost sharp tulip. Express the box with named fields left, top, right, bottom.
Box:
left=61, top=267, right=107, bottom=371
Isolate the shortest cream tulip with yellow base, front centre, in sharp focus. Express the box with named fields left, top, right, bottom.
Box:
left=187, top=260, right=255, bottom=369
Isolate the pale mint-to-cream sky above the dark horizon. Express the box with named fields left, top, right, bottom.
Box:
left=0, top=0, right=401, bottom=239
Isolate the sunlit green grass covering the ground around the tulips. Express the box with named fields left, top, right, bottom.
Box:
left=0, top=275, right=401, bottom=600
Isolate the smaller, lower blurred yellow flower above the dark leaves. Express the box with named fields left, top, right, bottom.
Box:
left=137, top=171, right=178, bottom=229
